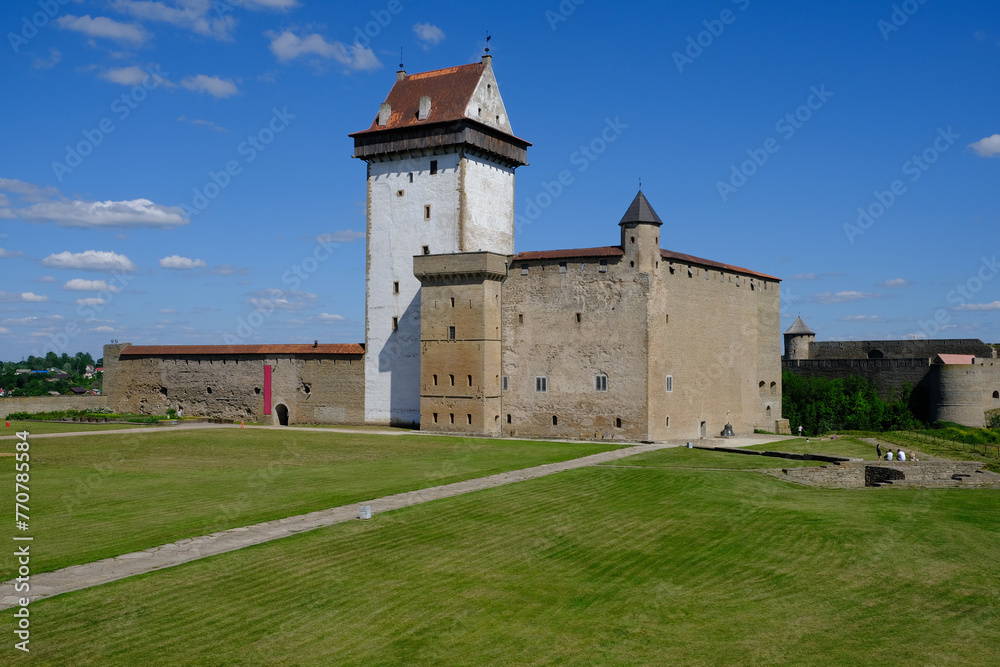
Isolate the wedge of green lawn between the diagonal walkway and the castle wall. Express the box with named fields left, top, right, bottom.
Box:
left=0, top=428, right=616, bottom=580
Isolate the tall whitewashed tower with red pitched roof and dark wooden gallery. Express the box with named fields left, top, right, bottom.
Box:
left=350, top=55, right=531, bottom=425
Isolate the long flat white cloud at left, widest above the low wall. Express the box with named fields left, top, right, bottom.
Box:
left=17, top=199, right=189, bottom=228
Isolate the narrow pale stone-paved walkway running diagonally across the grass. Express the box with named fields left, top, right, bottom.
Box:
left=0, top=429, right=781, bottom=609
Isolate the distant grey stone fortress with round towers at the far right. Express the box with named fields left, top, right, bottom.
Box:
left=781, top=317, right=1000, bottom=426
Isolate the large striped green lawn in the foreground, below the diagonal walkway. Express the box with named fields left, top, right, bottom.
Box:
left=25, top=467, right=1000, bottom=665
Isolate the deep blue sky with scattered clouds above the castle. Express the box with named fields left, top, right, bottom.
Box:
left=0, top=0, right=1000, bottom=360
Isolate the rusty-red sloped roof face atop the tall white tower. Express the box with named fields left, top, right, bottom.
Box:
left=349, top=63, right=486, bottom=137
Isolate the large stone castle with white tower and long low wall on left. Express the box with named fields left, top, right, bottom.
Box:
left=104, top=55, right=787, bottom=440
